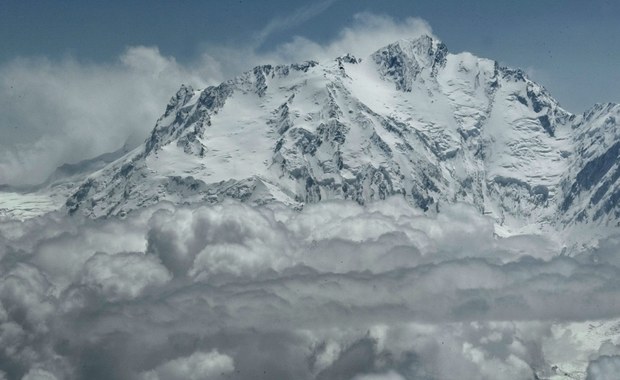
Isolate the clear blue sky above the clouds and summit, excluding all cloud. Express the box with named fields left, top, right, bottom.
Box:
left=0, top=0, right=620, bottom=112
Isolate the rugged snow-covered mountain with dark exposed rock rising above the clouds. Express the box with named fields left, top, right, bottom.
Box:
left=42, top=36, right=620, bottom=238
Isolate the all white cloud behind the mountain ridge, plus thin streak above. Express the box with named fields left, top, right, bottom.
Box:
left=0, top=13, right=431, bottom=185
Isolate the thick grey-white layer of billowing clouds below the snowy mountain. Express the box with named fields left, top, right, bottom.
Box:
left=0, top=199, right=620, bottom=380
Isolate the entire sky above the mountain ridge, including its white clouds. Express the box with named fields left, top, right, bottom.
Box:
left=0, top=0, right=620, bottom=185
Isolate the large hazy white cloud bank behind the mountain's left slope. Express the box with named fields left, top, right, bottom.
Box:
left=0, top=47, right=213, bottom=184
